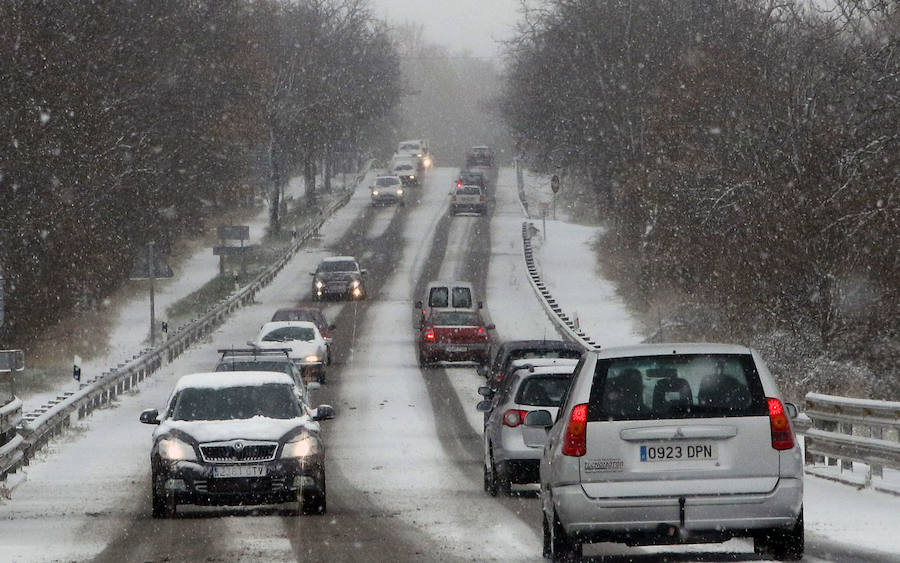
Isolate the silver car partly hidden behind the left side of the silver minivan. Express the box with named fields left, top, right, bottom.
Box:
left=477, top=360, right=577, bottom=496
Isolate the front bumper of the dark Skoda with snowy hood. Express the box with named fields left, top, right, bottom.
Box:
left=158, top=459, right=323, bottom=506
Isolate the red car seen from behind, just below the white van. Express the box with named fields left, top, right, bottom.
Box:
left=419, top=310, right=494, bottom=367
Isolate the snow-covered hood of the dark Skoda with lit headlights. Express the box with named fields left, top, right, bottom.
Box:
left=156, top=416, right=319, bottom=443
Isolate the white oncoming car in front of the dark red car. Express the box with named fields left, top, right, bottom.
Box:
left=248, top=321, right=328, bottom=383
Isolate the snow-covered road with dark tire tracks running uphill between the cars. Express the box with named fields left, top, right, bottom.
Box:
left=0, top=165, right=900, bottom=562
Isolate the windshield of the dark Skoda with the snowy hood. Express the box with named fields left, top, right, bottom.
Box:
left=171, top=383, right=300, bottom=424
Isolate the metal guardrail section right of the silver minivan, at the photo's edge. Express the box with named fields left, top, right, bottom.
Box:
left=795, top=393, right=900, bottom=484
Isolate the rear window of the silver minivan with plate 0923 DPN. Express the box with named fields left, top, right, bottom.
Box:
left=588, top=354, right=768, bottom=421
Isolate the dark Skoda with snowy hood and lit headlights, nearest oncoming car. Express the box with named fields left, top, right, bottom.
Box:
left=140, top=371, right=334, bottom=518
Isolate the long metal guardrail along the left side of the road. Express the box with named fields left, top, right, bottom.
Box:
left=0, top=177, right=367, bottom=480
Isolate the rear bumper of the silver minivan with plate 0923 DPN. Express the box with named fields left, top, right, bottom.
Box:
left=552, top=479, right=803, bottom=544
